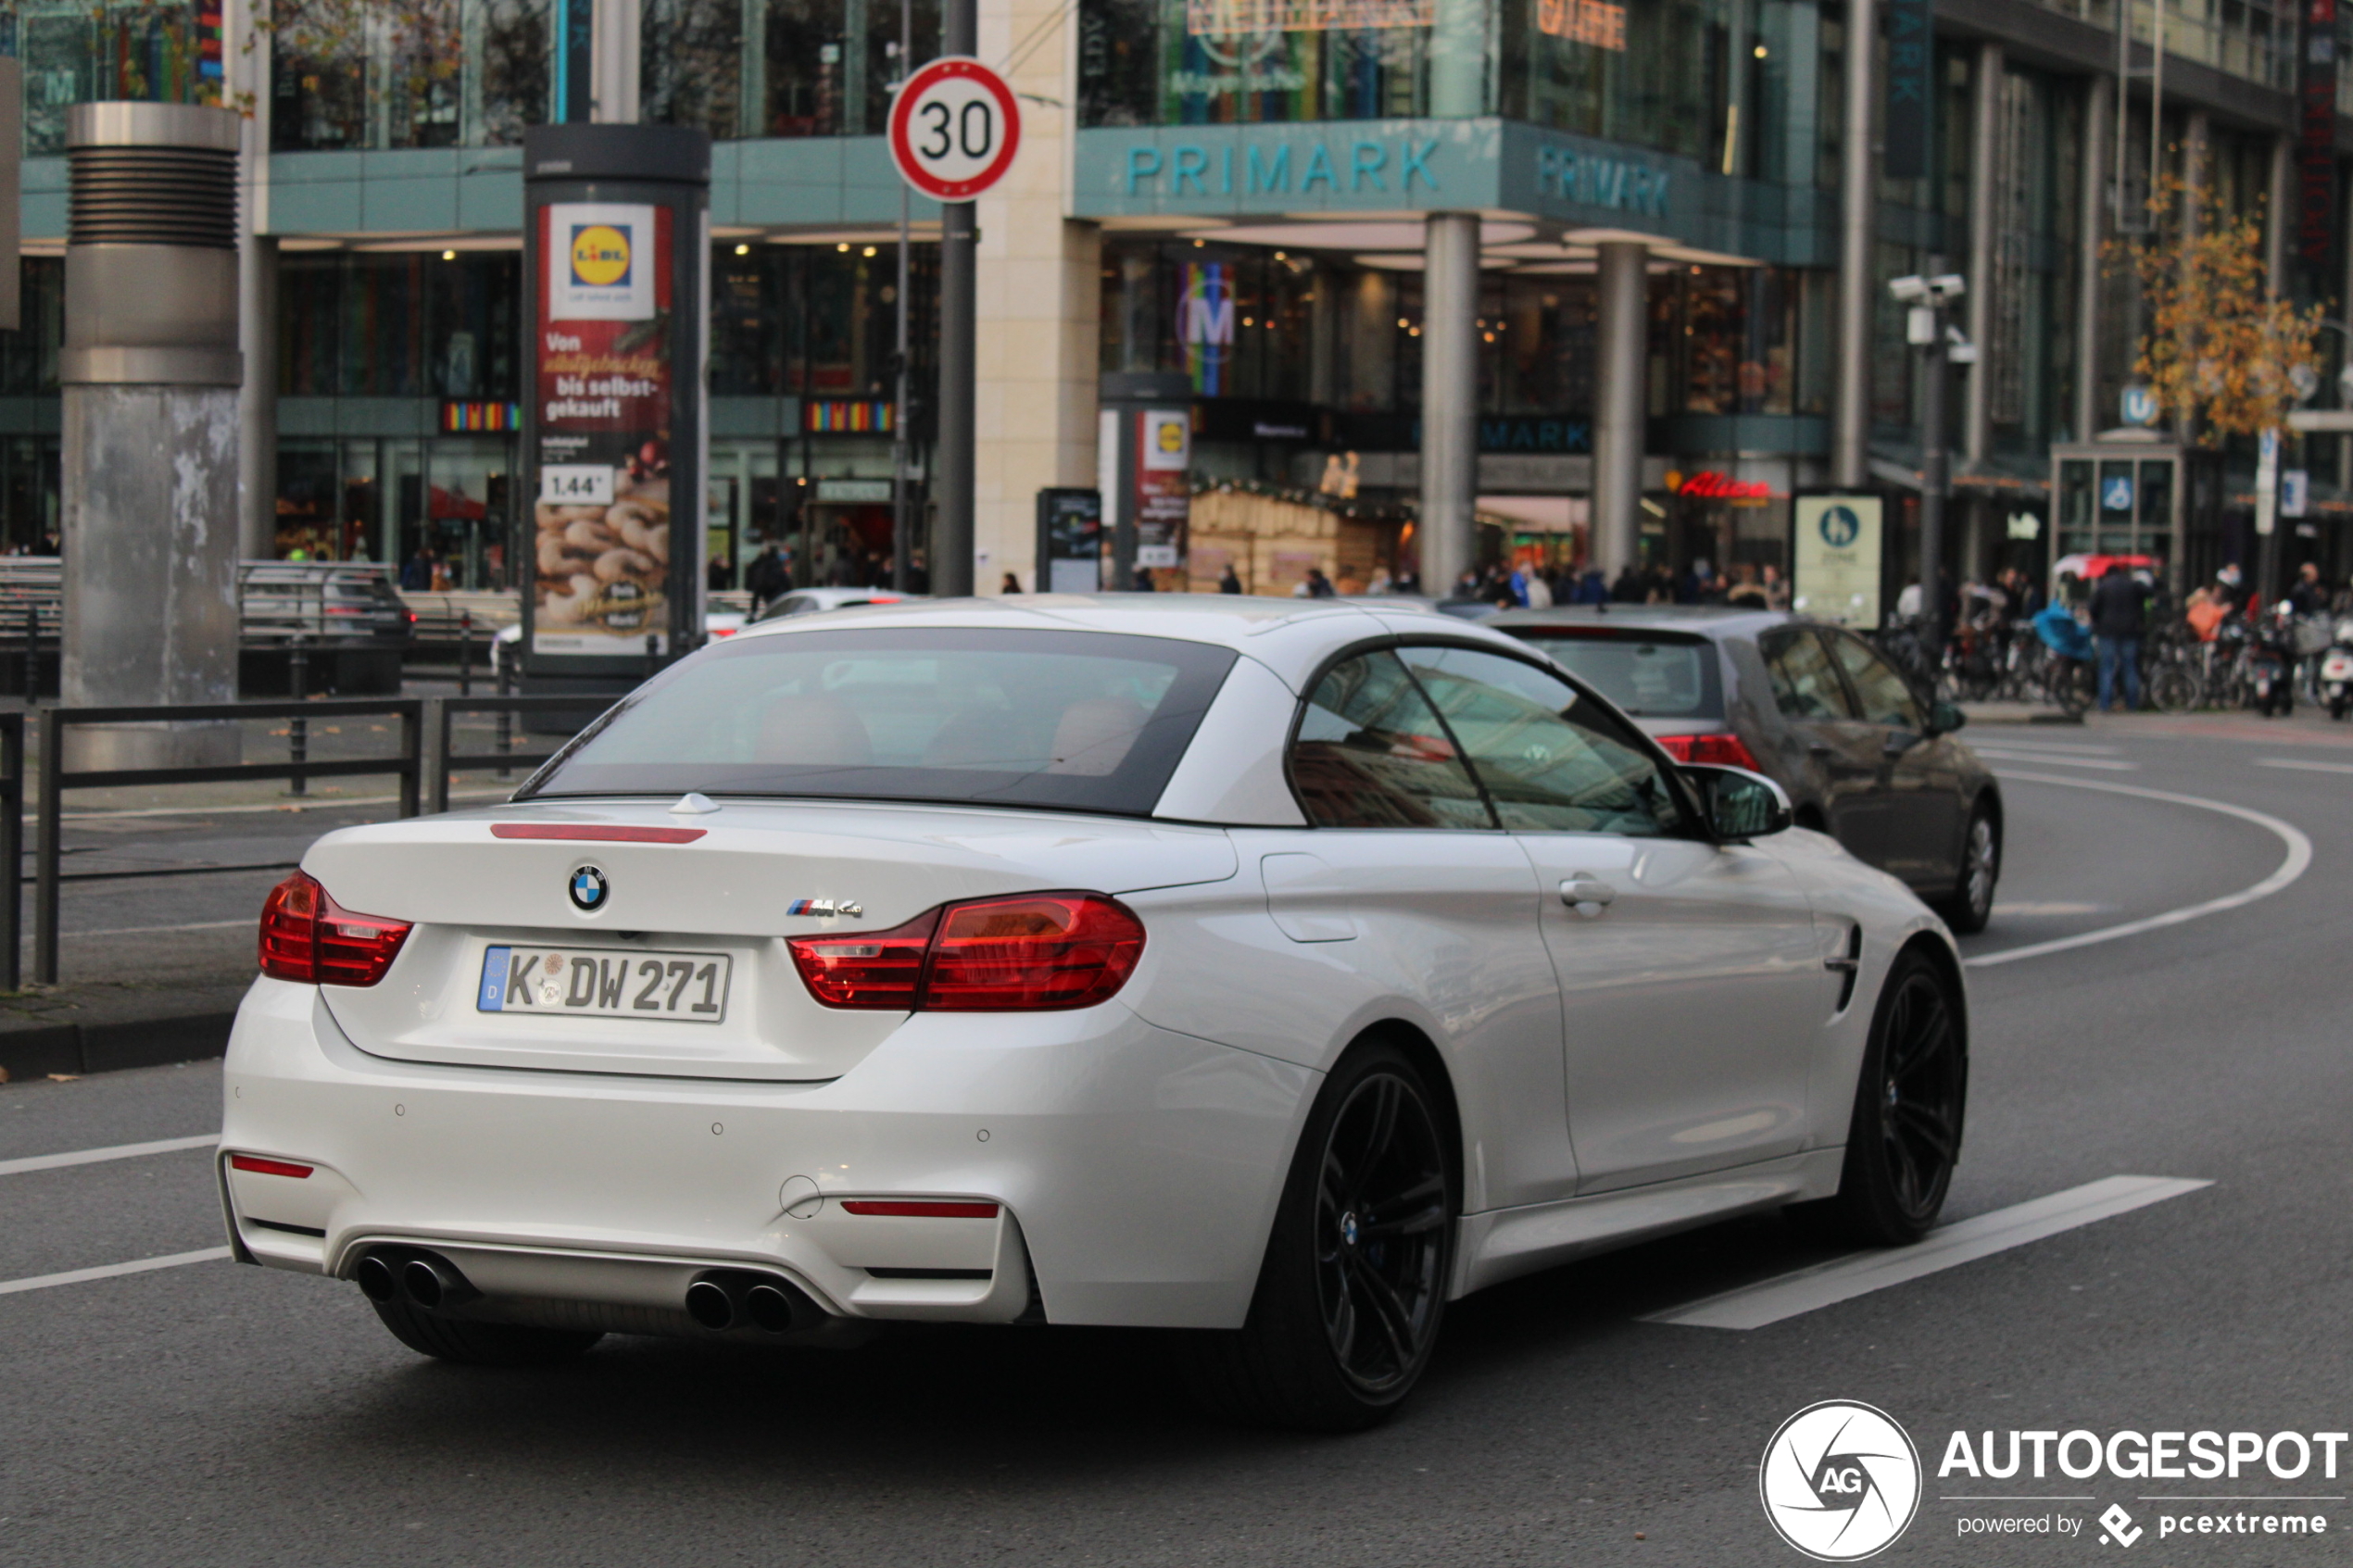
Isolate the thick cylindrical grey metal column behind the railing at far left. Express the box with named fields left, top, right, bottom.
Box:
left=59, top=104, right=243, bottom=766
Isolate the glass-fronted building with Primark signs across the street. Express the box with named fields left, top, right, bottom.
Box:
left=0, top=0, right=2353, bottom=588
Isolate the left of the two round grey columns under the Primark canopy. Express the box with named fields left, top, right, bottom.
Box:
left=1416, top=211, right=1478, bottom=599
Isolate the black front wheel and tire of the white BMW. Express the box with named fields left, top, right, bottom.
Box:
left=1788, top=949, right=1969, bottom=1246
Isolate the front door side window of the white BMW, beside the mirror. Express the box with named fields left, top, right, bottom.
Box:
left=1403, top=649, right=1687, bottom=837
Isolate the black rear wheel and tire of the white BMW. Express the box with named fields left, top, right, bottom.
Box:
left=1189, top=1041, right=1459, bottom=1432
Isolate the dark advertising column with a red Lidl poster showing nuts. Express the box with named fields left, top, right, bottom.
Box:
left=518, top=125, right=711, bottom=696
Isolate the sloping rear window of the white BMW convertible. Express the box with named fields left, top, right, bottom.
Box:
left=527, top=625, right=1236, bottom=816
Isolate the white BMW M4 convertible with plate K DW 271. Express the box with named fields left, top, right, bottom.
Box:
left=219, top=595, right=1967, bottom=1429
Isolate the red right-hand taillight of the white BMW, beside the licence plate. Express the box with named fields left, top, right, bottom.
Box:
left=786, top=894, right=1143, bottom=1013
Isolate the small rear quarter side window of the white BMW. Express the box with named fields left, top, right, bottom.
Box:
left=1291, top=654, right=1494, bottom=827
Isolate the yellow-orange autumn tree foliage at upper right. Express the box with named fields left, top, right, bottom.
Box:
left=2127, top=176, right=2322, bottom=442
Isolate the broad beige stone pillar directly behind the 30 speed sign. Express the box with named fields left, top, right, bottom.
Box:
left=964, top=0, right=1101, bottom=595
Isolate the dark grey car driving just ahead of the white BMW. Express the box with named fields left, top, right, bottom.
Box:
left=1485, top=604, right=2003, bottom=931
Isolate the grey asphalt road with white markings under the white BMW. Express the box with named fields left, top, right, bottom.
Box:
left=0, top=721, right=2353, bottom=1568
